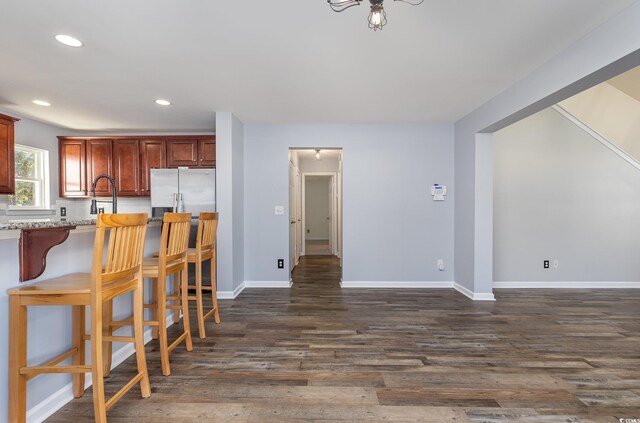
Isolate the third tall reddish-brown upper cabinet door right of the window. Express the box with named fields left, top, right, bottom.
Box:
left=113, top=139, right=141, bottom=197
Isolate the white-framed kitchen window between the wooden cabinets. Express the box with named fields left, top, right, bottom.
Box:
left=9, top=144, right=49, bottom=209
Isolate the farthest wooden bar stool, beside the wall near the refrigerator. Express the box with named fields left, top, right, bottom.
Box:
left=188, top=212, right=220, bottom=338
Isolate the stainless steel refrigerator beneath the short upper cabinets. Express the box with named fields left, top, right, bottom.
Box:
left=151, top=168, right=216, bottom=215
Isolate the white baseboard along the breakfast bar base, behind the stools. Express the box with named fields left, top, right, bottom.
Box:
left=27, top=314, right=173, bottom=423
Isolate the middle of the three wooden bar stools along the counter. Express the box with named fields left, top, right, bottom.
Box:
left=108, top=213, right=193, bottom=376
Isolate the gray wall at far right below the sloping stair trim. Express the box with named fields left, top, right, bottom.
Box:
left=493, top=109, right=640, bottom=282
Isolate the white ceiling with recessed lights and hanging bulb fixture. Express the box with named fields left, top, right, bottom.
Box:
left=0, top=0, right=634, bottom=132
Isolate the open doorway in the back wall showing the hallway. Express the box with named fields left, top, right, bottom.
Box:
left=289, top=147, right=342, bottom=282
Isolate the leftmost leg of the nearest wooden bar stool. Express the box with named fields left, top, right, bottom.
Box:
left=9, top=295, right=27, bottom=423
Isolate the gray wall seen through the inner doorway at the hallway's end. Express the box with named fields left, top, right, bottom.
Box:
left=304, top=176, right=331, bottom=240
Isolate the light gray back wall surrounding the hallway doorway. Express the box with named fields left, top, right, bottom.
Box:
left=244, top=124, right=454, bottom=281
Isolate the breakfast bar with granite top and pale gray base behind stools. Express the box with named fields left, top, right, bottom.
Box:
left=0, top=218, right=162, bottom=421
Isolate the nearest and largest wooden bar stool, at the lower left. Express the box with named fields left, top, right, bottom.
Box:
left=7, top=213, right=151, bottom=423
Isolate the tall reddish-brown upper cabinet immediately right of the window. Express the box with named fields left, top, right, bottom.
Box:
left=58, top=137, right=87, bottom=197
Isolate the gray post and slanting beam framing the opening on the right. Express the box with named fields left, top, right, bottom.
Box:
left=455, top=2, right=640, bottom=294
